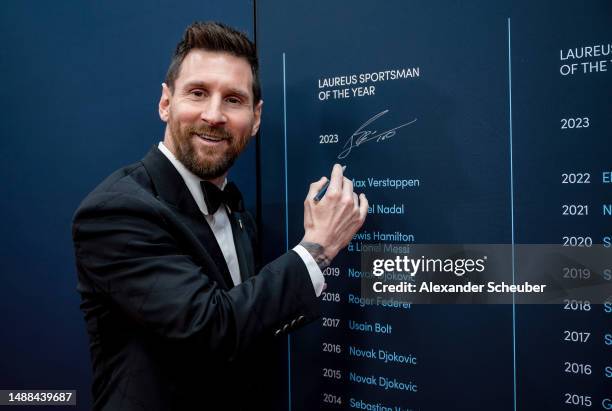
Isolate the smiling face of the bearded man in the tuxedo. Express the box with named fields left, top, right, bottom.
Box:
left=159, top=49, right=262, bottom=181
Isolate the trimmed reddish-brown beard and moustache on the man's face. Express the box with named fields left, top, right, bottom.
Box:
left=170, top=121, right=248, bottom=180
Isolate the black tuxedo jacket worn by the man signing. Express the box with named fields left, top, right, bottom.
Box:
left=73, top=147, right=319, bottom=411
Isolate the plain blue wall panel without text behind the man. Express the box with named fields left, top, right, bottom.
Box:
left=0, top=0, right=255, bottom=410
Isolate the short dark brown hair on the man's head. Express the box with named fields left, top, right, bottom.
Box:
left=165, top=21, right=261, bottom=106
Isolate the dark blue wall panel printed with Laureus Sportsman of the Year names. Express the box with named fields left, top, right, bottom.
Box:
left=257, top=0, right=612, bottom=411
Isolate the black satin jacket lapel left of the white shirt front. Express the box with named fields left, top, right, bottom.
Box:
left=142, top=147, right=235, bottom=289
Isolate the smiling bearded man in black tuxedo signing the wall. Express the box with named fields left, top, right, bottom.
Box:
left=73, top=23, right=368, bottom=411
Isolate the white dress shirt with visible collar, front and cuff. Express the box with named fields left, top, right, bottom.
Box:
left=157, top=142, right=325, bottom=297
